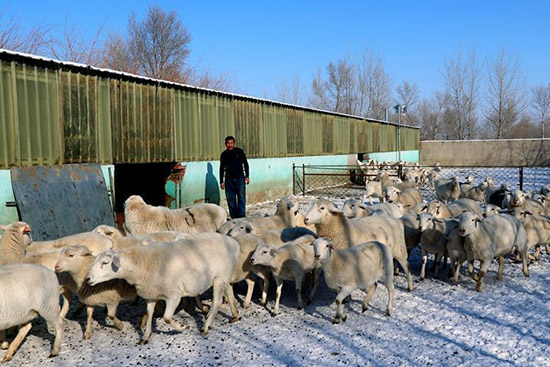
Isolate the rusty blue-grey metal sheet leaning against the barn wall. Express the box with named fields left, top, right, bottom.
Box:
left=11, top=164, right=115, bottom=241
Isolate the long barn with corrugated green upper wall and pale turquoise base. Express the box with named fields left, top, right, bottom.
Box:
left=0, top=50, right=419, bottom=229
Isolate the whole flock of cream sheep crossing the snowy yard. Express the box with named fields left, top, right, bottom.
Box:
left=0, top=161, right=550, bottom=361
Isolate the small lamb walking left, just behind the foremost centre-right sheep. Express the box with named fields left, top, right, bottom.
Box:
left=250, top=236, right=320, bottom=315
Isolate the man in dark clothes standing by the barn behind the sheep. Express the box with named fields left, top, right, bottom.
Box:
left=220, top=136, right=250, bottom=218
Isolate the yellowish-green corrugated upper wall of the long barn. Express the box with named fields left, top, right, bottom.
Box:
left=0, top=52, right=419, bottom=168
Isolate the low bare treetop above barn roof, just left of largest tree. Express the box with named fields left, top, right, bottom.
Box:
left=45, top=18, right=103, bottom=66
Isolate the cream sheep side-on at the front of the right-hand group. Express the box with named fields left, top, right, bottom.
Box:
left=458, top=211, right=529, bottom=292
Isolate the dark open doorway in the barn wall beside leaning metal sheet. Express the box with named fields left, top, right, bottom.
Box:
left=115, top=162, right=176, bottom=225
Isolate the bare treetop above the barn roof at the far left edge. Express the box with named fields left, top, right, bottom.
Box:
left=0, top=11, right=50, bottom=54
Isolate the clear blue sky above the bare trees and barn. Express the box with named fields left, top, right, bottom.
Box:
left=0, top=0, right=550, bottom=102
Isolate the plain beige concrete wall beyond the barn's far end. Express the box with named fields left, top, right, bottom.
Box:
left=420, top=139, right=550, bottom=167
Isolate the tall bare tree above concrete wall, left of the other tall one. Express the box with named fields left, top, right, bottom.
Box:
left=442, top=50, right=481, bottom=139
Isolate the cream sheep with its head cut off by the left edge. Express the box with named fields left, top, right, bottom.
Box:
left=0, top=264, right=63, bottom=362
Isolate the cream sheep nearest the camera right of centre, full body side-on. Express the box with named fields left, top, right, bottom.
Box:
left=312, top=238, right=395, bottom=324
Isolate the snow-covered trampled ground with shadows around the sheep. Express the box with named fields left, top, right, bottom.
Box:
left=6, top=197, right=550, bottom=367
